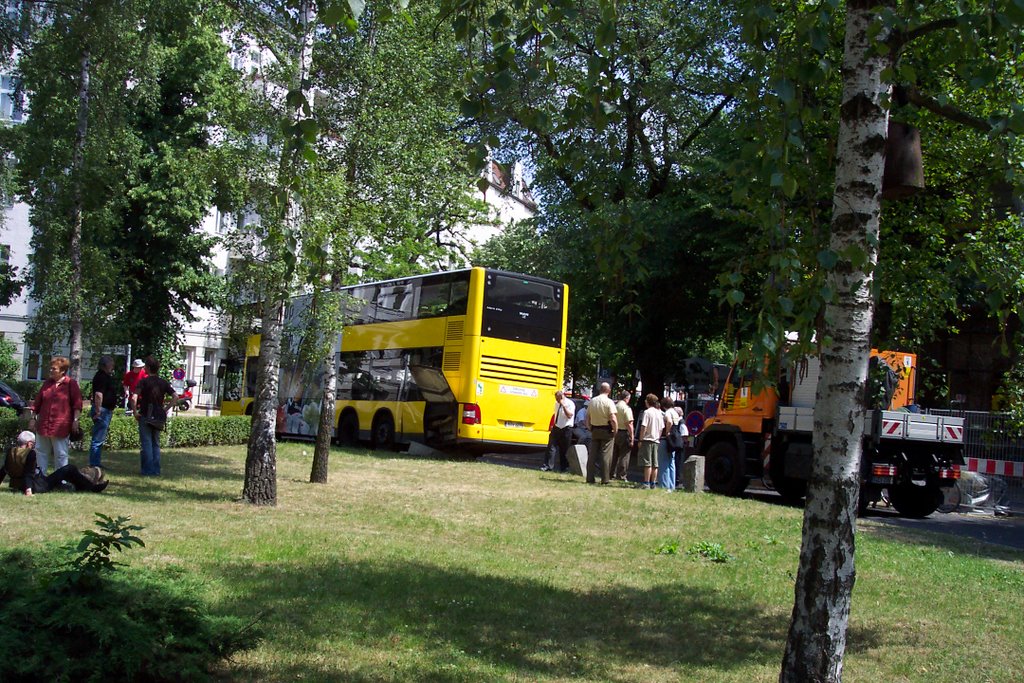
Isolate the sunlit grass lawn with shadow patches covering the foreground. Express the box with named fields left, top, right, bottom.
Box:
left=0, top=443, right=1024, bottom=683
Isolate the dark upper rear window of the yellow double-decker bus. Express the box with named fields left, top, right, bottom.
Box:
left=481, top=270, right=562, bottom=346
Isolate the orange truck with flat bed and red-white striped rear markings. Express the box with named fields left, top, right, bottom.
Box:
left=696, top=349, right=964, bottom=517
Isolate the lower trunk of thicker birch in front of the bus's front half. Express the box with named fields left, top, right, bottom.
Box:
left=242, top=301, right=285, bottom=505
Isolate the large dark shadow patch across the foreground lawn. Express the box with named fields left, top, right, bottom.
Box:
left=216, top=562, right=879, bottom=681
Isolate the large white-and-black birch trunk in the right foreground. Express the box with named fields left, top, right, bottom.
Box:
left=779, top=0, right=892, bottom=683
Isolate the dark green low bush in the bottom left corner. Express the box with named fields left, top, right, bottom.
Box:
left=0, top=513, right=255, bottom=682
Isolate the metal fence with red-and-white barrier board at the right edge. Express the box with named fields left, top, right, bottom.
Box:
left=927, top=410, right=1024, bottom=514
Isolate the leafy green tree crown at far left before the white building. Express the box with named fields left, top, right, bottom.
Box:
left=15, top=0, right=249, bottom=352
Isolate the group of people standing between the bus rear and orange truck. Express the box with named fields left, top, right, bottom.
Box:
left=542, top=382, right=689, bottom=490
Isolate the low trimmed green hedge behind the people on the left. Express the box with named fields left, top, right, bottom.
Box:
left=0, top=412, right=252, bottom=451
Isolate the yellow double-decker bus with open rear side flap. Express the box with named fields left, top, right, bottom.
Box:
left=221, top=268, right=568, bottom=450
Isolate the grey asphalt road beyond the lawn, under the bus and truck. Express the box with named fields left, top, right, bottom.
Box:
left=480, top=451, right=1024, bottom=551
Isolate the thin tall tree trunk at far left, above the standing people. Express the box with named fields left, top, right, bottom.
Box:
left=69, top=47, right=91, bottom=382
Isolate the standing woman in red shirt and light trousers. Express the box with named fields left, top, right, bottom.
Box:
left=29, top=355, right=82, bottom=474
